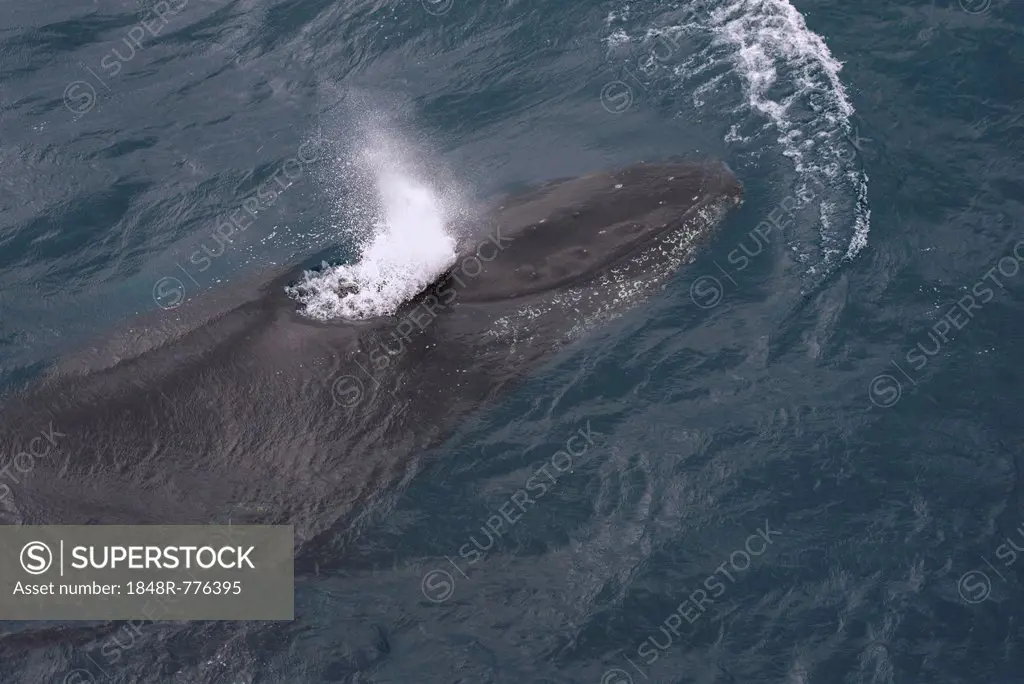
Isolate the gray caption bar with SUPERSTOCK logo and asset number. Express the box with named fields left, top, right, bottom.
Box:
left=0, top=525, right=295, bottom=621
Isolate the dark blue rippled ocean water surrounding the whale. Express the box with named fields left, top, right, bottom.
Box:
left=0, top=0, right=1024, bottom=684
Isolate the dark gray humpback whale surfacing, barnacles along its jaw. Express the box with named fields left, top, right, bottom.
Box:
left=0, top=162, right=742, bottom=573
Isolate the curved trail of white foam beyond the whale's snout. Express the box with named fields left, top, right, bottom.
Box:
left=608, top=0, right=870, bottom=276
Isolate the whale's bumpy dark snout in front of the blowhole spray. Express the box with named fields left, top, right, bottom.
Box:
left=419, top=163, right=742, bottom=317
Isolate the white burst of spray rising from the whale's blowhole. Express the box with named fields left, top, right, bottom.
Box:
left=289, top=139, right=456, bottom=320
